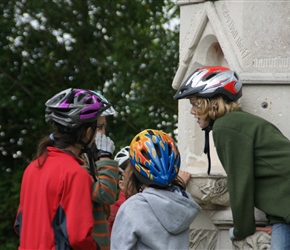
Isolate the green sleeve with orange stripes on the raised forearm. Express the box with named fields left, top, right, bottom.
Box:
left=92, top=160, right=119, bottom=204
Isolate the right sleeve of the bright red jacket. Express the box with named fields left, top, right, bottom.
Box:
left=60, top=167, right=98, bottom=250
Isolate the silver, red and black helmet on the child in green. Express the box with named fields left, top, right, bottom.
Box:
left=174, top=66, right=242, bottom=101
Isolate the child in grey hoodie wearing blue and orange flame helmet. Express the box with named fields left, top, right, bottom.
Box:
left=111, top=129, right=201, bottom=250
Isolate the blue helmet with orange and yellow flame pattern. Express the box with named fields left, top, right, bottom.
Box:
left=130, top=129, right=180, bottom=187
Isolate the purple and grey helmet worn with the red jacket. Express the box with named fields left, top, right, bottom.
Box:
left=45, top=88, right=110, bottom=129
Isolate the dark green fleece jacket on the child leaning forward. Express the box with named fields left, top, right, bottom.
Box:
left=213, top=111, right=290, bottom=239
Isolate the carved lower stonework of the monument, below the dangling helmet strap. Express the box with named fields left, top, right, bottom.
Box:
left=187, top=174, right=270, bottom=250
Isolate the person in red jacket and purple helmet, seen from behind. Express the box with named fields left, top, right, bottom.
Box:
left=14, top=88, right=109, bottom=250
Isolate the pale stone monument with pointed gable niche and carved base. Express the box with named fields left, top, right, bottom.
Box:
left=172, top=0, right=290, bottom=249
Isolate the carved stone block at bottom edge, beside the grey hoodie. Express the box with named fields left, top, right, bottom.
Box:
left=189, top=229, right=218, bottom=250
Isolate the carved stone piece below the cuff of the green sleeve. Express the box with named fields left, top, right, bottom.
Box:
left=233, top=232, right=271, bottom=250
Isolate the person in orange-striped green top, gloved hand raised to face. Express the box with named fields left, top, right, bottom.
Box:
left=83, top=91, right=119, bottom=250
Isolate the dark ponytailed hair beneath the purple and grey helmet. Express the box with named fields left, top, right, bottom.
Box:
left=35, top=121, right=97, bottom=167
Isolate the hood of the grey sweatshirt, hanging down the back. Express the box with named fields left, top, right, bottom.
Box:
left=141, top=188, right=201, bottom=234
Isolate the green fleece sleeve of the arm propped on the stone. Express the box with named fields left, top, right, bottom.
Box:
left=213, top=127, right=255, bottom=240
